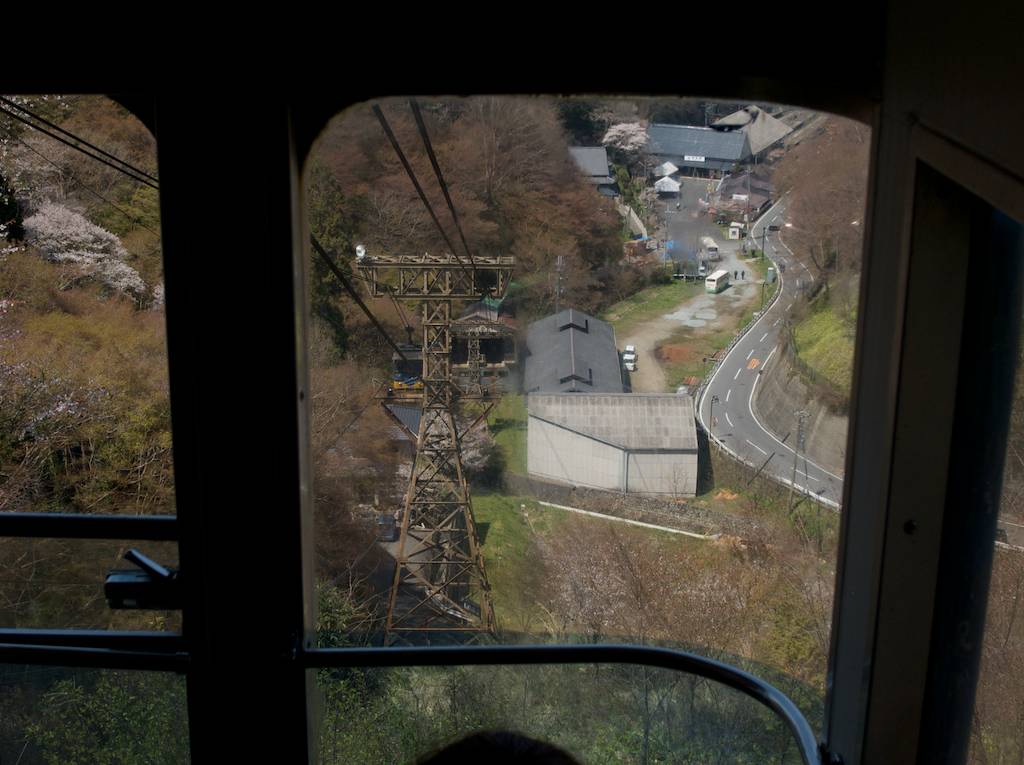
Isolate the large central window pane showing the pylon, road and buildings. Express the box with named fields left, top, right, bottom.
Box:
left=304, top=97, right=870, bottom=729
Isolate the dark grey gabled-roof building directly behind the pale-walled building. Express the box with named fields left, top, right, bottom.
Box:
left=523, top=308, right=623, bottom=393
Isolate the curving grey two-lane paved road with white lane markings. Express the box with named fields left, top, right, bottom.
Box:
left=697, top=203, right=843, bottom=508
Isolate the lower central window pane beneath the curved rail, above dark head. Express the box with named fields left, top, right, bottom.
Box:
left=319, top=665, right=806, bottom=763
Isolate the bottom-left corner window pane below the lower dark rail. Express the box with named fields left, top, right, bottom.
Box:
left=0, top=665, right=189, bottom=765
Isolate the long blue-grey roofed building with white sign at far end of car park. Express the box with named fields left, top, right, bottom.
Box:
left=645, top=123, right=751, bottom=175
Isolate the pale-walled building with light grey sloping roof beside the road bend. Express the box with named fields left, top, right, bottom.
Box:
left=526, top=393, right=697, bottom=497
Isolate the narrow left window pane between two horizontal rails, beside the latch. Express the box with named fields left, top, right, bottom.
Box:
left=0, top=539, right=181, bottom=631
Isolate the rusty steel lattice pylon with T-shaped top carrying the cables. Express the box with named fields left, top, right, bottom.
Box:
left=357, top=255, right=514, bottom=644
